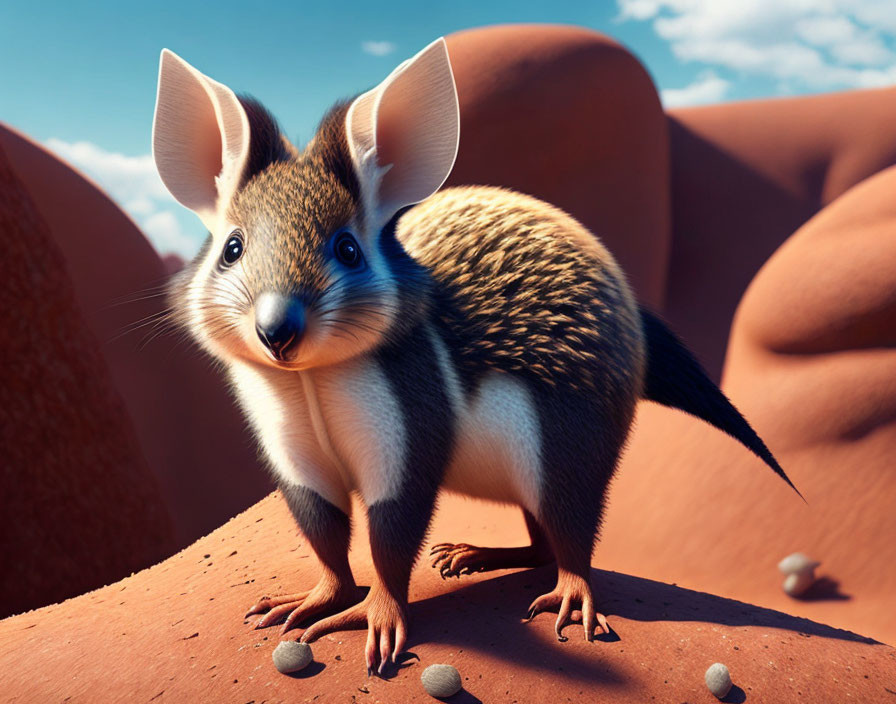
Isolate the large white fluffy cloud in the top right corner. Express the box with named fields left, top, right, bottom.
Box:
left=617, top=0, right=896, bottom=90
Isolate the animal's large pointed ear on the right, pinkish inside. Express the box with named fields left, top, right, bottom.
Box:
left=345, top=38, right=460, bottom=231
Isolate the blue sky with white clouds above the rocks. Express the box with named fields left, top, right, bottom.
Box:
left=0, top=0, right=896, bottom=255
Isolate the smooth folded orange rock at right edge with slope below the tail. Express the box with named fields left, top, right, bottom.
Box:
left=597, top=162, right=896, bottom=643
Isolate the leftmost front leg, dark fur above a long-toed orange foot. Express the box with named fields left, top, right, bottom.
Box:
left=247, top=482, right=361, bottom=632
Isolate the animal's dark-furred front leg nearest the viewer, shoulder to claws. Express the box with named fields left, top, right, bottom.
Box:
left=302, top=327, right=454, bottom=674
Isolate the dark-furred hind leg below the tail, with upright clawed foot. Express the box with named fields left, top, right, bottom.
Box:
left=527, top=393, right=634, bottom=641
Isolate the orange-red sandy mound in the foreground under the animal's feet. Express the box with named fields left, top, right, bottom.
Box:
left=0, top=495, right=896, bottom=704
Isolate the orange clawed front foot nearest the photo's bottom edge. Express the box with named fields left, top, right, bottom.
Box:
left=300, top=589, right=408, bottom=676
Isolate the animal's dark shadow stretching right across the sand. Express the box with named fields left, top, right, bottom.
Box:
left=409, top=567, right=878, bottom=688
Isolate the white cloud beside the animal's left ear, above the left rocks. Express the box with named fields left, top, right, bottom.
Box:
left=46, top=138, right=203, bottom=259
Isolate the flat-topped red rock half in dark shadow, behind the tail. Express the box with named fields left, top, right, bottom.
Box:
left=664, top=88, right=896, bottom=378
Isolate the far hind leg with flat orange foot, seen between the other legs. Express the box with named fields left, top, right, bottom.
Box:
left=429, top=509, right=554, bottom=579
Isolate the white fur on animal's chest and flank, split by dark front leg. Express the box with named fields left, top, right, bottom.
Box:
left=230, top=345, right=542, bottom=515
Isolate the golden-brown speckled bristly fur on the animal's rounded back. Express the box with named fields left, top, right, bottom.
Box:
left=398, top=187, right=644, bottom=402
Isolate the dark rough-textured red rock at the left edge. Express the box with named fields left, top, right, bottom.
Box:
left=0, top=144, right=175, bottom=616
